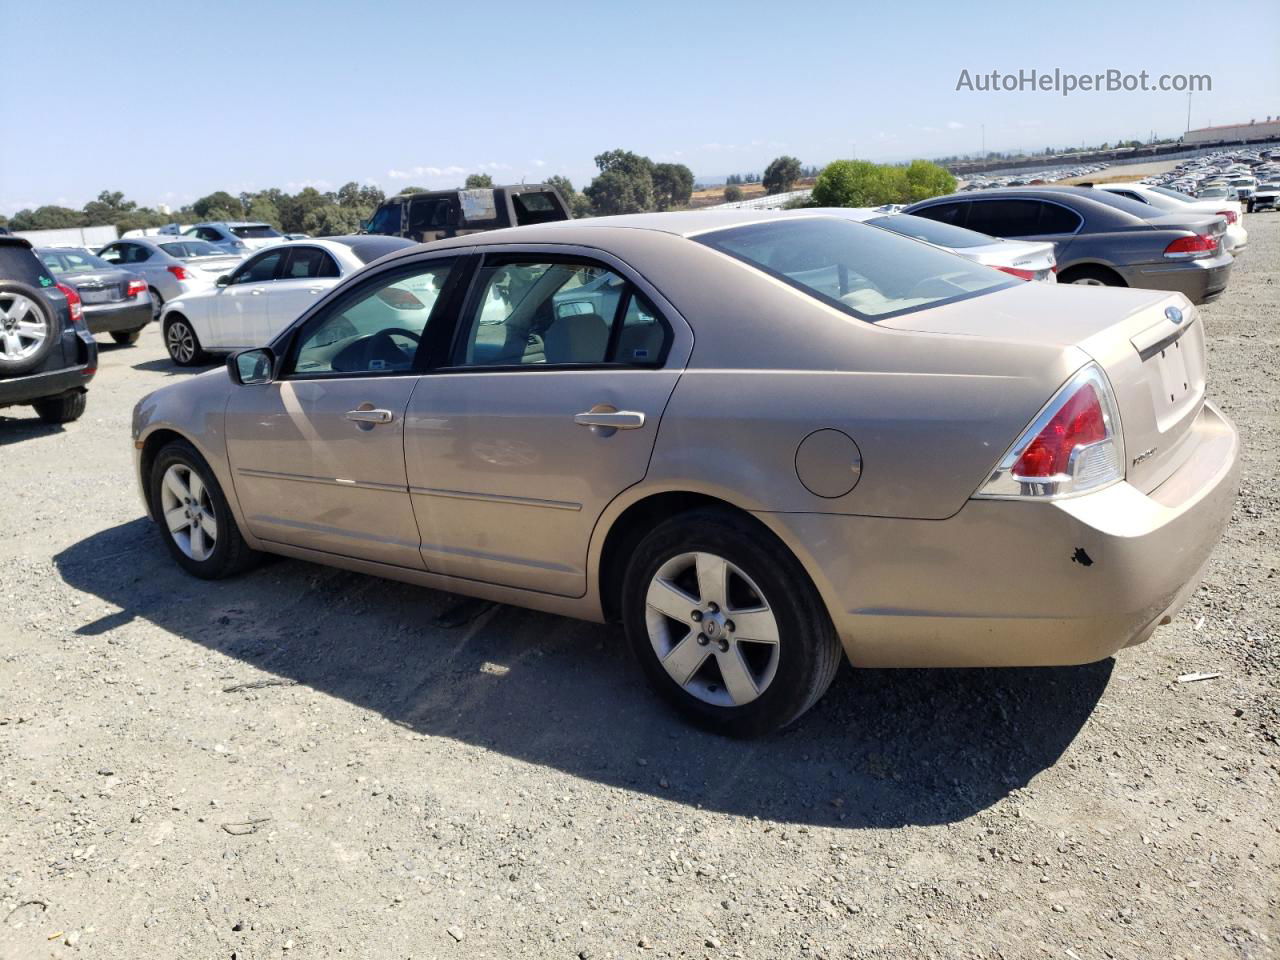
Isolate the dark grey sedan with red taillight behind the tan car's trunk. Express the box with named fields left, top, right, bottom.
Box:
left=906, top=187, right=1233, bottom=303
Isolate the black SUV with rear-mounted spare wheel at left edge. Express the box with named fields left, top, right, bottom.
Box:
left=0, top=234, right=97, bottom=424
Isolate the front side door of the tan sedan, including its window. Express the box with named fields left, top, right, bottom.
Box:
left=225, top=257, right=463, bottom=570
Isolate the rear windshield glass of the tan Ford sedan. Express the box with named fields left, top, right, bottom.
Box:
left=695, top=218, right=1020, bottom=320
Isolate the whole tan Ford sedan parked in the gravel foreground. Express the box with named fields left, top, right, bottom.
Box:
left=133, top=210, right=1239, bottom=735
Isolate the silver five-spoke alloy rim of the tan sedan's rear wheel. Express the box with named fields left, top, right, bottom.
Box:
left=645, top=552, right=781, bottom=707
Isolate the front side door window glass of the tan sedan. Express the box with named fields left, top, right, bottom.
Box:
left=291, top=261, right=452, bottom=376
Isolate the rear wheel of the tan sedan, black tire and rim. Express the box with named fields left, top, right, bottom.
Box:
left=622, top=508, right=841, bottom=737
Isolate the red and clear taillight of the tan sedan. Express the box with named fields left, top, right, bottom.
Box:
left=974, top=364, right=1124, bottom=499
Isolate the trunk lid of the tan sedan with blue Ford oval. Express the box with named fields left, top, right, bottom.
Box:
left=878, top=283, right=1204, bottom=493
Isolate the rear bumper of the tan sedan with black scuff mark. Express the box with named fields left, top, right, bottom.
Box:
left=758, top=404, right=1239, bottom=667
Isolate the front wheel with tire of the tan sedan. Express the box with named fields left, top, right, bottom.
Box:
left=148, top=440, right=259, bottom=580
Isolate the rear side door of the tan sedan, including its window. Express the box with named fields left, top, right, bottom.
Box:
left=404, top=248, right=692, bottom=596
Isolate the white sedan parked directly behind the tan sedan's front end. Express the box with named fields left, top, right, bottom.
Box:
left=160, top=236, right=413, bottom=366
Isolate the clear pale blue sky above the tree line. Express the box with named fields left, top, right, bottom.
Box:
left=0, top=0, right=1280, bottom=214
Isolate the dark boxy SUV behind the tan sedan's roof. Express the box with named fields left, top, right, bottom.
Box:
left=362, top=183, right=571, bottom=243
